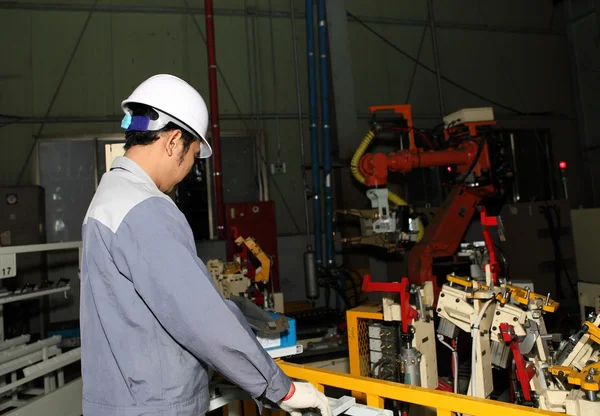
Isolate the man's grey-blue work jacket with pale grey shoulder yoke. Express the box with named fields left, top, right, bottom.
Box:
left=80, top=157, right=290, bottom=416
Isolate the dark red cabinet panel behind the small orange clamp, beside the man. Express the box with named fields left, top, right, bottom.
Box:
left=225, top=201, right=279, bottom=292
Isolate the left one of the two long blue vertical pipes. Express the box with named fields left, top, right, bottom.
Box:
left=306, top=0, right=323, bottom=264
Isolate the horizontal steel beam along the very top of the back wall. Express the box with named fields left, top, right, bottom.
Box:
left=0, top=1, right=566, bottom=36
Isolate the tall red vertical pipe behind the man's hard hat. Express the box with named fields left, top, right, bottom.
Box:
left=204, top=0, right=225, bottom=240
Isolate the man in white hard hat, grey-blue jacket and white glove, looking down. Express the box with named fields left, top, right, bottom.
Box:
left=80, top=75, right=331, bottom=416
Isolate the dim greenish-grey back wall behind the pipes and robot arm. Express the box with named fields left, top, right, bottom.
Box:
left=0, top=0, right=585, bottom=240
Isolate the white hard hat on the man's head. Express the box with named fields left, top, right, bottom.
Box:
left=121, top=74, right=212, bottom=159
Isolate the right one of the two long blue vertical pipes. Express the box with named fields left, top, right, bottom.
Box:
left=317, top=0, right=334, bottom=266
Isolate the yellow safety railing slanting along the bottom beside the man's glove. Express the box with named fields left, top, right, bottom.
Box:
left=278, top=361, right=559, bottom=416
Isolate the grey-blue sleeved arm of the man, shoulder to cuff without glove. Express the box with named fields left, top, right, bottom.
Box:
left=111, top=198, right=291, bottom=403
